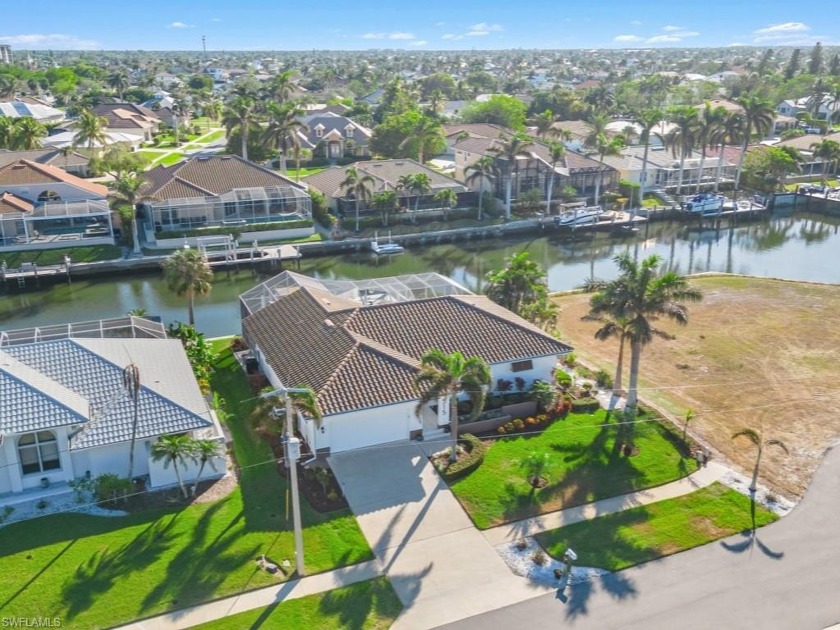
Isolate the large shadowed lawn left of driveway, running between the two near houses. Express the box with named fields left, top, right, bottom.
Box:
left=0, top=340, right=372, bottom=628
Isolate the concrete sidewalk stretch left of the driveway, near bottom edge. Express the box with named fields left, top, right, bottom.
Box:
left=119, top=560, right=382, bottom=630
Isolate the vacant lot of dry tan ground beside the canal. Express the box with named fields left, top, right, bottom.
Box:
left=557, top=276, right=840, bottom=502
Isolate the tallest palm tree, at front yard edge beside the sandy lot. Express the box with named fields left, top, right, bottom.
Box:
left=589, top=252, right=703, bottom=414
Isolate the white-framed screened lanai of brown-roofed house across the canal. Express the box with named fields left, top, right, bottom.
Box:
left=146, top=186, right=312, bottom=232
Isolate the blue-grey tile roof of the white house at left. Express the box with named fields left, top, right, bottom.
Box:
left=0, top=339, right=213, bottom=449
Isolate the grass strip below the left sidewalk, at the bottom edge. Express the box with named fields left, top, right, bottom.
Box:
left=196, top=577, right=402, bottom=630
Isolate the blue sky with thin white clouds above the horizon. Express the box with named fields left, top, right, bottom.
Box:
left=0, top=0, right=840, bottom=50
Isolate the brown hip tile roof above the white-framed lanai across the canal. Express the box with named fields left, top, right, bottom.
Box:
left=142, top=155, right=298, bottom=199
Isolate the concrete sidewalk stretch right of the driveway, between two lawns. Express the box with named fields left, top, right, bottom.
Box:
left=482, top=462, right=729, bottom=546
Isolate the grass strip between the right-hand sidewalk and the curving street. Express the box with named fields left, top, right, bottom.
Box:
left=536, top=483, right=778, bottom=571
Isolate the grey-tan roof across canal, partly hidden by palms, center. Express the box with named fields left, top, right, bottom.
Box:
left=303, top=159, right=467, bottom=197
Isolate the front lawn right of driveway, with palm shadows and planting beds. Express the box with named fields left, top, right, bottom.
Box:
left=452, top=410, right=697, bottom=529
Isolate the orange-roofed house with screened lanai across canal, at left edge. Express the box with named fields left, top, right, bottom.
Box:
left=0, top=160, right=114, bottom=251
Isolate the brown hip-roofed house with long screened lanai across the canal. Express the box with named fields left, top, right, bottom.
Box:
left=140, top=155, right=312, bottom=244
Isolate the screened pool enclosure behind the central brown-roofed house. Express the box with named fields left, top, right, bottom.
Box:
left=239, top=271, right=472, bottom=317
